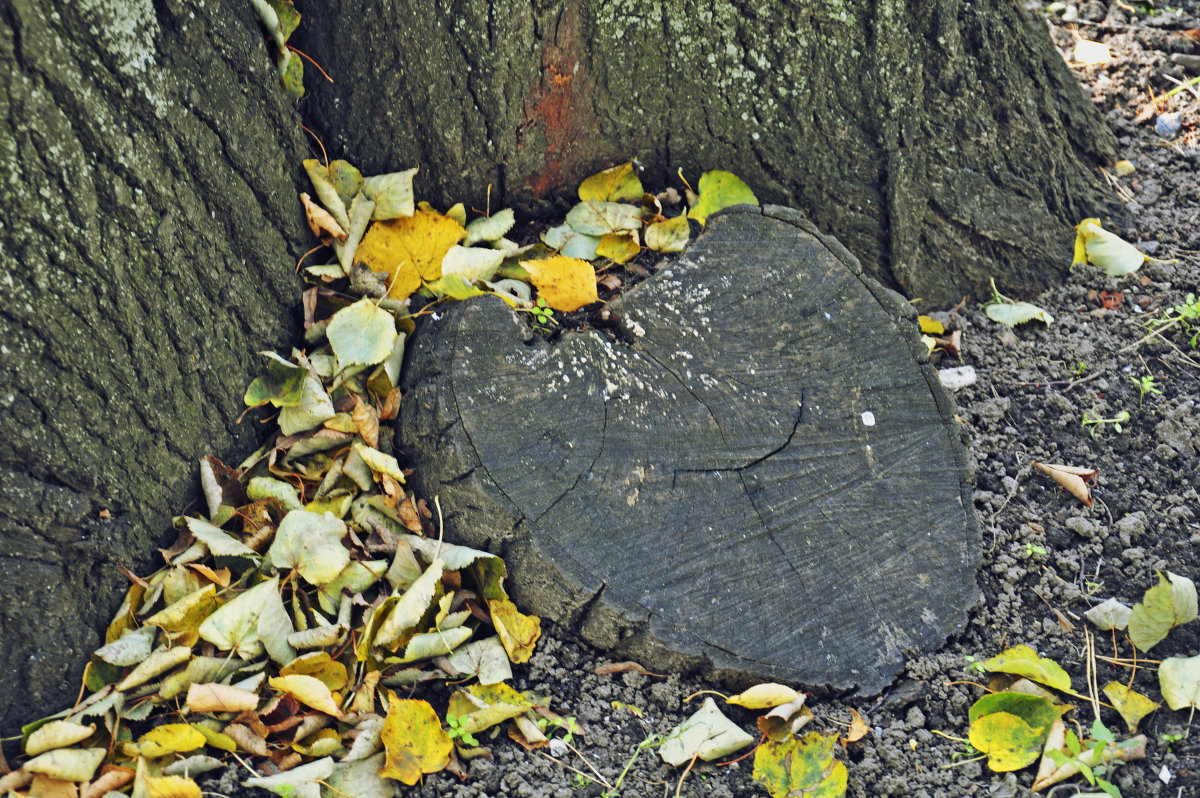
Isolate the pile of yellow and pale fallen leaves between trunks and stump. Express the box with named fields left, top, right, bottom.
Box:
left=0, top=161, right=756, bottom=798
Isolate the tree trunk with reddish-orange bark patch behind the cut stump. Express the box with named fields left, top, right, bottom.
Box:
left=298, top=0, right=1114, bottom=302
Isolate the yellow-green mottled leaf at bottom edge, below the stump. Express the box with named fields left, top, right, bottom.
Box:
left=754, top=732, right=848, bottom=798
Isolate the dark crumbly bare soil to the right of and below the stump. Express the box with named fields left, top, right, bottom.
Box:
left=199, top=1, right=1200, bottom=798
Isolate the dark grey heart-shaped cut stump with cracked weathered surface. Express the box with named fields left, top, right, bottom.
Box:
left=400, top=206, right=979, bottom=692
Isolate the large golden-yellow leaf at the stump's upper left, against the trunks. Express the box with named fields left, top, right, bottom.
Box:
left=354, top=210, right=467, bottom=299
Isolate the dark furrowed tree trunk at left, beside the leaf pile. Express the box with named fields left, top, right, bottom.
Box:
left=0, top=0, right=304, bottom=734
